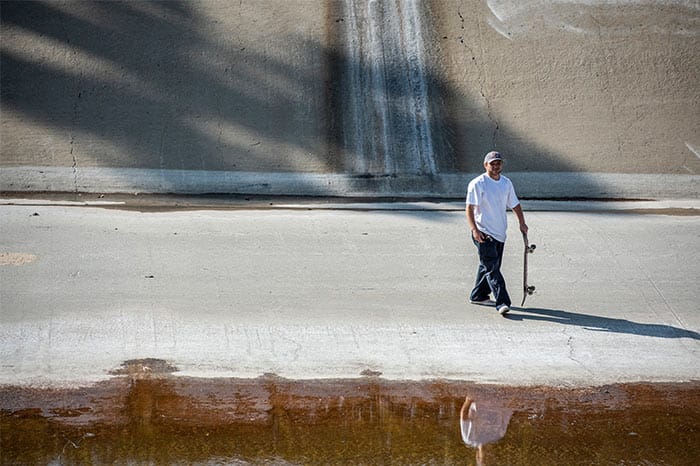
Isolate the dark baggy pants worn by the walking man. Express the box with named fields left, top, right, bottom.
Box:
left=469, top=237, right=511, bottom=307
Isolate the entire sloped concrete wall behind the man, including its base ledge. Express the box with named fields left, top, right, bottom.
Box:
left=0, top=0, right=700, bottom=197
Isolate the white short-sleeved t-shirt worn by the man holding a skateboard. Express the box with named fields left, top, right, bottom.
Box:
left=467, top=173, right=520, bottom=243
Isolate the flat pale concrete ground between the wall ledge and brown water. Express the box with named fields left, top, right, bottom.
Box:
left=0, top=199, right=700, bottom=386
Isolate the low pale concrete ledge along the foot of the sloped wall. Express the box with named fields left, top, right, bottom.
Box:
left=0, top=166, right=700, bottom=199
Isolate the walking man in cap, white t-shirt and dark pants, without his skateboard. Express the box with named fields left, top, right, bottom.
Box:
left=466, top=151, right=528, bottom=315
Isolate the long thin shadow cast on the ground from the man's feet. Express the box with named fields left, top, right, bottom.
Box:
left=506, top=308, right=700, bottom=340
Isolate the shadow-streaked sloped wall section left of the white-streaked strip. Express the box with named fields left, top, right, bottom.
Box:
left=2, top=0, right=328, bottom=171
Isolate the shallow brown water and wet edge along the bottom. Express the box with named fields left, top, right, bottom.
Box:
left=0, top=366, right=700, bottom=465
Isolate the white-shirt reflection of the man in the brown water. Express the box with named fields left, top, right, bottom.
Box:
left=459, top=397, right=513, bottom=466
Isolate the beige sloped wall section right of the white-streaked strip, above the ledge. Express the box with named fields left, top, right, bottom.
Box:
left=435, top=0, right=700, bottom=175
